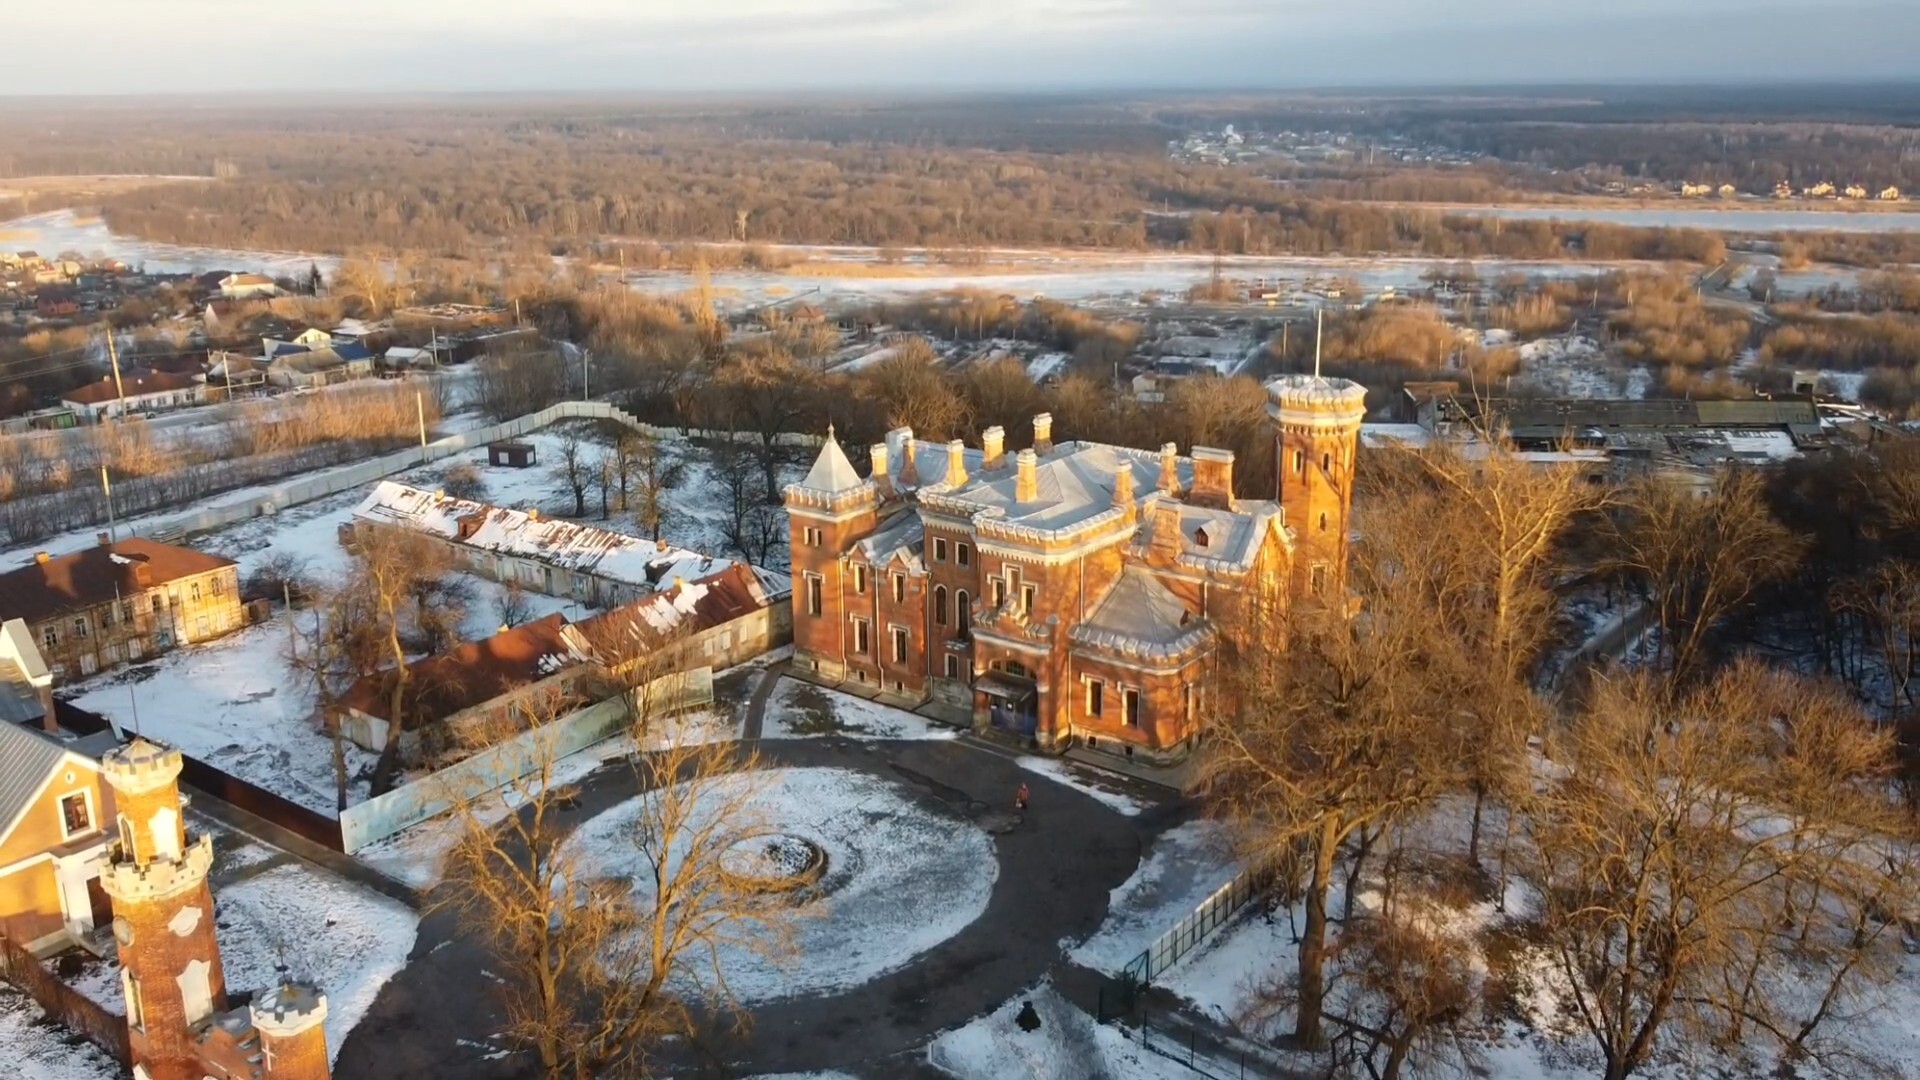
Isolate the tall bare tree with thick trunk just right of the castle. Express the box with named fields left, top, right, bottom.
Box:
left=1198, top=519, right=1469, bottom=1049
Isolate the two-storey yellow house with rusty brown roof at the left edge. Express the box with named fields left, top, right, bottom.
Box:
left=0, top=532, right=246, bottom=682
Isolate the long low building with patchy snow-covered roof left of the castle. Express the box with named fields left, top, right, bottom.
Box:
left=353, top=480, right=732, bottom=607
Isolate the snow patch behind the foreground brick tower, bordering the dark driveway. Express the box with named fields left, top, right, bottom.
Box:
left=58, top=861, right=420, bottom=1053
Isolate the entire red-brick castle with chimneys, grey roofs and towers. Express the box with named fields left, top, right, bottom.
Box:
left=787, top=377, right=1365, bottom=761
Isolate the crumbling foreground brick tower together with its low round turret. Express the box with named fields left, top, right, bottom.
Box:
left=100, top=738, right=328, bottom=1080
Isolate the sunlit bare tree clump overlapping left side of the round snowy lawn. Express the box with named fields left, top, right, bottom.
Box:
left=445, top=728, right=795, bottom=1080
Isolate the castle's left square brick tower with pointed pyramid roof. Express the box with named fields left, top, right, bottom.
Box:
left=785, top=427, right=879, bottom=678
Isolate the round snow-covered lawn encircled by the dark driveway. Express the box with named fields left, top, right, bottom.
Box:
left=566, top=769, right=998, bottom=1003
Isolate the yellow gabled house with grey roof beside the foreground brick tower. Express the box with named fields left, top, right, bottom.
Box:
left=0, top=723, right=113, bottom=955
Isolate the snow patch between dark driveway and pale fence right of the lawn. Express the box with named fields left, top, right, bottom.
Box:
left=1068, top=821, right=1240, bottom=974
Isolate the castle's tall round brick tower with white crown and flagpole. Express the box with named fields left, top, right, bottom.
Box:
left=1267, top=375, right=1367, bottom=598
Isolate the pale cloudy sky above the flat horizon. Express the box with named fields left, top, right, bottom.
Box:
left=0, top=0, right=1920, bottom=94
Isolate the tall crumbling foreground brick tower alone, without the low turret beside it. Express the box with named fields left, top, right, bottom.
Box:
left=100, top=738, right=227, bottom=1080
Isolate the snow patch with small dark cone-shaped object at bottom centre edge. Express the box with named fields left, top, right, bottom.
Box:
left=927, top=982, right=1204, bottom=1080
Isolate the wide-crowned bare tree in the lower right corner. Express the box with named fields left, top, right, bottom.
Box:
left=1528, top=663, right=1910, bottom=1080
